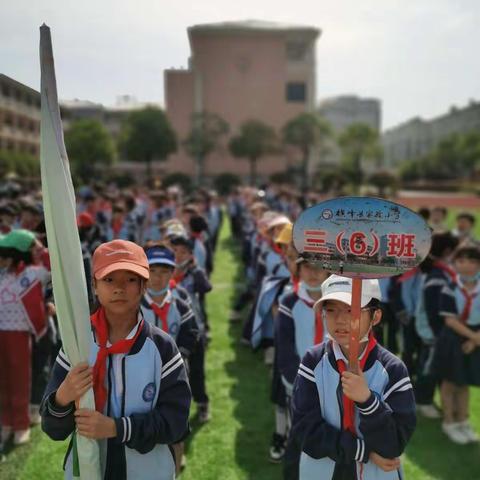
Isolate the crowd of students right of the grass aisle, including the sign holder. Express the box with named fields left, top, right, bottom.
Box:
left=228, top=189, right=480, bottom=480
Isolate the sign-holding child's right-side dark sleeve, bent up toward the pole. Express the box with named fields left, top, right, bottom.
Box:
left=356, top=355, right=416, bottom=458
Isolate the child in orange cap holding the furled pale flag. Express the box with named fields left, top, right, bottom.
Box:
left=42, top=240, right=191, bottom=480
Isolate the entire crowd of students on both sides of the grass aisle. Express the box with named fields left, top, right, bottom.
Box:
left=0, top=181, right=480, bottom=480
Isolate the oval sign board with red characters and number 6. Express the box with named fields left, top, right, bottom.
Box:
left=293, top=197, right=431, bottom=278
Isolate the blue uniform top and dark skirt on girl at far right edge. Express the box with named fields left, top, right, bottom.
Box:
left=433, top=279, right=480, bottom=386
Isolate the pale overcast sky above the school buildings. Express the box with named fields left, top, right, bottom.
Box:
left=0, top=0, right=480, bottom=129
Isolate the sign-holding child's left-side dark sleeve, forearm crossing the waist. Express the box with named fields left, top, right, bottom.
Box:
left=291, top=346, right=369, bottom=464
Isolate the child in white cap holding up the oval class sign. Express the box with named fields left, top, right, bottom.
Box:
left=290, top=275, right=416, bottom=480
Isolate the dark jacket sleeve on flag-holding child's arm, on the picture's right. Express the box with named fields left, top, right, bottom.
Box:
left=115, top=332, right=191, bottom=453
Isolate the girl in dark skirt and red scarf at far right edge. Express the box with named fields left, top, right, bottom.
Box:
left=433, top=246, right=480, bottom=444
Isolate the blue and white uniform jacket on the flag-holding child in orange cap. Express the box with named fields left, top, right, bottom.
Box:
left=41, top=317, right=191, bottom=480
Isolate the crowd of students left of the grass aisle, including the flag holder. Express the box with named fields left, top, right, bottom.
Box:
left=0, top=183, right=223, bottom=478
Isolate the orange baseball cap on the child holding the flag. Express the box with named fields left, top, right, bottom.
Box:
left=92, top=240, right=150, bottom=280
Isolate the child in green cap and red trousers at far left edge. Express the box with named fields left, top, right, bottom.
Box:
left=0, top=230, right=50, bottom=445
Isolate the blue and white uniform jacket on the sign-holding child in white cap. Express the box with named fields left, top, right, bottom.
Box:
left=291, top=341, right=416, bottom=480
